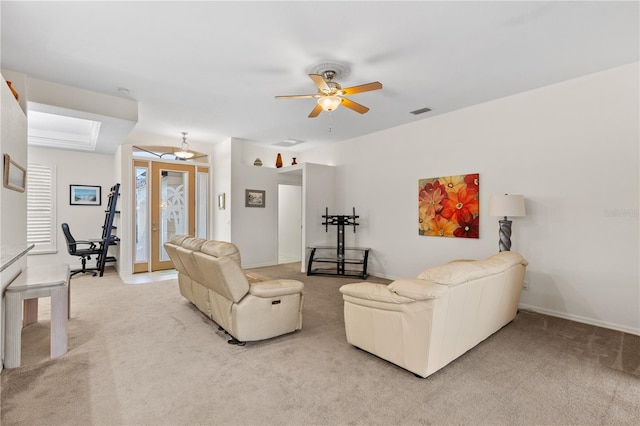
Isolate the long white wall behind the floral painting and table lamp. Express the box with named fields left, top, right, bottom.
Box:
left=305, top=63, right=640, bottom=334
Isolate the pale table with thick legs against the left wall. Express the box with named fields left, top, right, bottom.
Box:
left=4, top=264, right=69, bottom=368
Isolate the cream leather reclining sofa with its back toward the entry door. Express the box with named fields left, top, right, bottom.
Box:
left=164, top=235, right=304, bottom=344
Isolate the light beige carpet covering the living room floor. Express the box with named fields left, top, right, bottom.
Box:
left=0, top=264, right=640, bottom=426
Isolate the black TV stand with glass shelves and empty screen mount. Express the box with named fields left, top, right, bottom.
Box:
left=307, top=207, right=370, bottom=279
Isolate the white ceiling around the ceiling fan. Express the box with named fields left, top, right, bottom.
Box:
left=0, top=1, right=640, bottom=151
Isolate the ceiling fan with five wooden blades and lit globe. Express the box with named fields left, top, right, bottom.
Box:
left=276, top=70, right=382, bottom=118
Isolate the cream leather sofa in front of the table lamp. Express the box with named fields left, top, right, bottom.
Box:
left=340, top=252, right=527, bottom=377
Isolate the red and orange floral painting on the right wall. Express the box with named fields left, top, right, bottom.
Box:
left=418, top=173, right=480, bottom=238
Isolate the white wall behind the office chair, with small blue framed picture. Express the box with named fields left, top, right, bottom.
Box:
left=28, top=147, right=119, bottom=269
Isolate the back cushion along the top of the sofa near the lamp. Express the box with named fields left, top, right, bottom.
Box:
left=418, top=251, right=527, bottom=285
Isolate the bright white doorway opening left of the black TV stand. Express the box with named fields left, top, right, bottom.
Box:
left=278, top=184, right=302, bottom=264
